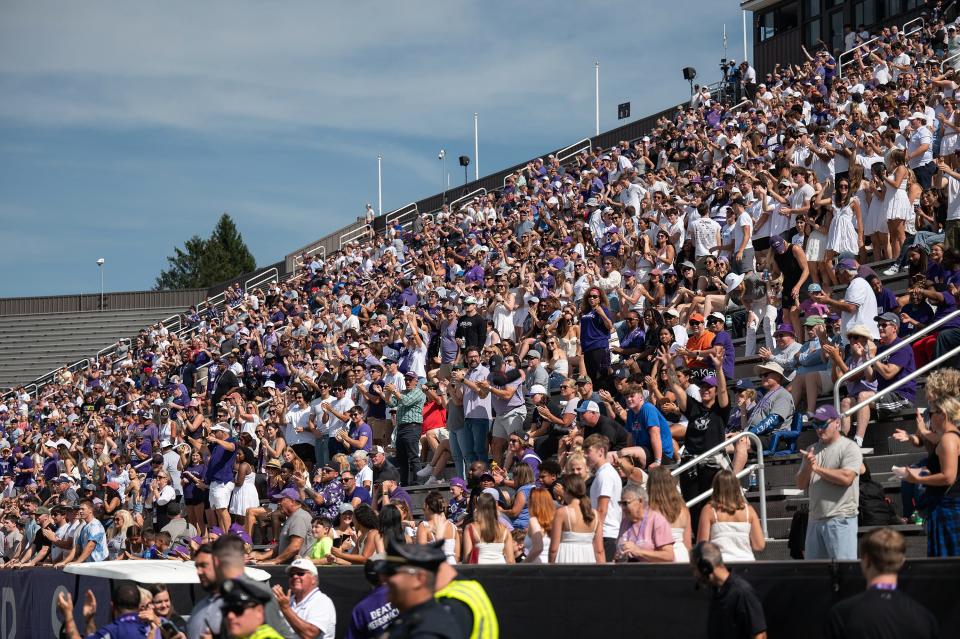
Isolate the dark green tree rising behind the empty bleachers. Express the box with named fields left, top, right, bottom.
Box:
left=155, top=213, right=257, bottom=290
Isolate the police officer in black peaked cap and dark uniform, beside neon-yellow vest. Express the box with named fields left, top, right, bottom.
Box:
left=377, top=541, right=469, bottom=639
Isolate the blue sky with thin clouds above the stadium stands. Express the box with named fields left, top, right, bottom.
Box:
left=0, top=0, right=743, bottom=297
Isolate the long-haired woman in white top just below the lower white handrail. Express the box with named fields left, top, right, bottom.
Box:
left=697, top=470, right=767, bottom=562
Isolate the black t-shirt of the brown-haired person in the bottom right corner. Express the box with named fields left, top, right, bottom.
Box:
left=823, top=588, right=940, bottom=639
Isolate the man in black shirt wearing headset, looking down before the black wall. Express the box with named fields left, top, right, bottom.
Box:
left=690, top=541, right=767, bottom=639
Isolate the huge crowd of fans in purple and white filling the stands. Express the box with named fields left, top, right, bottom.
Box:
left=0, top=3, right=960, bottom=636
